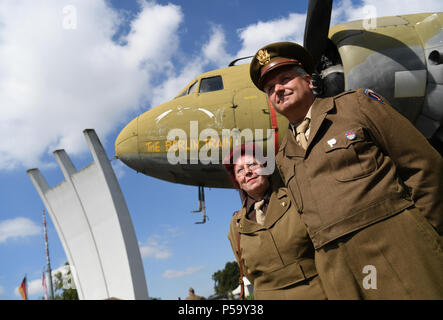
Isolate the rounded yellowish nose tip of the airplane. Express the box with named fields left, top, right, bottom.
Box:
left=115, top=117, right=139, bottom=167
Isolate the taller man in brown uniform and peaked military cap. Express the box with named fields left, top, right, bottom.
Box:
left=250, top=42, right=443, bottom=299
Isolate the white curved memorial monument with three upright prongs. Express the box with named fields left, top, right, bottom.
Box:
left=27, top=129, right=148, bottom=300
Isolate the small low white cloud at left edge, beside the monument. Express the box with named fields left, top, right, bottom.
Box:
left=0, top=217, right=41, bottom=243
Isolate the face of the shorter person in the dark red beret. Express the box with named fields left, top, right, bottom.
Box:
left=234, top=154, right=269, bottom=199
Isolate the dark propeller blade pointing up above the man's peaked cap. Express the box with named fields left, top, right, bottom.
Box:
left=303, top=0, right=332, bottom=64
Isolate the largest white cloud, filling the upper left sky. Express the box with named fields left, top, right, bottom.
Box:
left=0, top=0, right=183, bottom=170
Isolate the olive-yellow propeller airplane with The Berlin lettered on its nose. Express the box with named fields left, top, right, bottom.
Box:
left=115, top=0, right=443, bottom=222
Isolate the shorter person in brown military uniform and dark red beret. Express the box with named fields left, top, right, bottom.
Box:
left=225, top=145, right=326, bottom=300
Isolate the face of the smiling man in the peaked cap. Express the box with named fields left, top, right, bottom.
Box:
left=264, top=66, right=314, bottom=123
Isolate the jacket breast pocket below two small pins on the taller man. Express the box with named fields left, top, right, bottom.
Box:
left=324, top=127, right=377, bottom=182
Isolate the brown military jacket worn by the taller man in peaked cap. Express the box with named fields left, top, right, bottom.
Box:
left=276, top=89, right=443, bottom=248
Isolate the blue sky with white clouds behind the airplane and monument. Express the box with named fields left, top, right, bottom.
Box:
left=0, top=0, right=443, bottom=299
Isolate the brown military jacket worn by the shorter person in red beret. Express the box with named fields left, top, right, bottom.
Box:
left=228, top=188, right=324, bottom=299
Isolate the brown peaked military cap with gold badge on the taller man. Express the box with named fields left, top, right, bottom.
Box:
left=249, top=42, right=314, bottom=91
